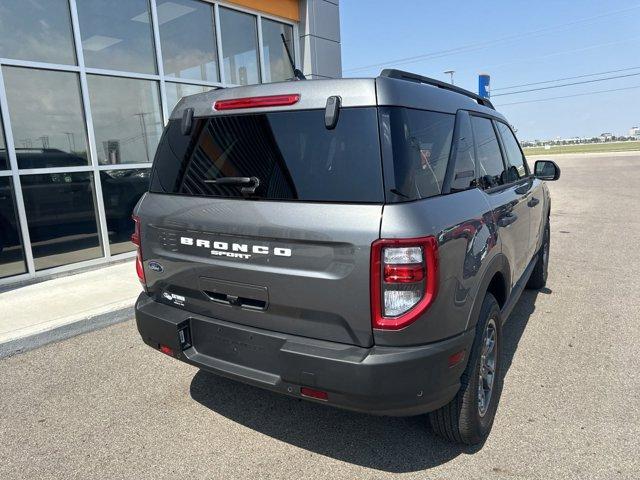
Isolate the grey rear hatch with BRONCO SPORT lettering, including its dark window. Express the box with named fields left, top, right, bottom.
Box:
left=137, top=103, right=384, bottom=346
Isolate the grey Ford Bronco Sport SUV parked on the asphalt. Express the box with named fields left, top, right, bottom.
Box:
left=132, top=70, right=560, bottom=444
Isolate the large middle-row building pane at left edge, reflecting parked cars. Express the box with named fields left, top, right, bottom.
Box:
left=2, top=67, right=89, bottom=168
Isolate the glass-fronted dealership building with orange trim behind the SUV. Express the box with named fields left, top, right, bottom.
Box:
left=0, top=0, right=342, bottom=285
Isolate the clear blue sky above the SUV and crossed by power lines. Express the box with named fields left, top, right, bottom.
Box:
left=340, top=0, right=640, bottom=140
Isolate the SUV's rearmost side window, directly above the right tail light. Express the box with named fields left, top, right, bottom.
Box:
left=389, top=107, right=456, bottom=200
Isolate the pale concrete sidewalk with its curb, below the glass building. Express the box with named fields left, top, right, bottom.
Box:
left=0, top=261, right=141, bottom=358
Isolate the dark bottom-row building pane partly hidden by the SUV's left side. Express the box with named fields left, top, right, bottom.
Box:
left=100, top=168, right=149, bottom=255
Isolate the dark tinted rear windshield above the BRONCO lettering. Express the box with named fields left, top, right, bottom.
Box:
left=150, top=107, right=384, bottom=203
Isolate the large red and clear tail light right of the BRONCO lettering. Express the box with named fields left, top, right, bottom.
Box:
left=371, top=237, right=438, bottom=330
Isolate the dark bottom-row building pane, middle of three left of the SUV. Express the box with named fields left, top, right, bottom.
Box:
left=20, top=172, right=102, bottom=270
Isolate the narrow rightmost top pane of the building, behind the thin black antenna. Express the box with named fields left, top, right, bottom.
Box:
left=262, top=18, right=295, bottom=82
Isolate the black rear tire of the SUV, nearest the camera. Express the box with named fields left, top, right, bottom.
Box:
left=429, top=293, right=502, bottom=445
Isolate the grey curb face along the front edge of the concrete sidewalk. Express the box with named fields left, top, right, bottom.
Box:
left=0, top=305, right=134, bottom=359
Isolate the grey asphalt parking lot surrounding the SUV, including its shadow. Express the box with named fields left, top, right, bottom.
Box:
left=0, top=153, right=640, bottom=479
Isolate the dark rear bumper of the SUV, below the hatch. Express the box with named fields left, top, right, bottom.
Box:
left=135, top=293, right=474, bottom=416
